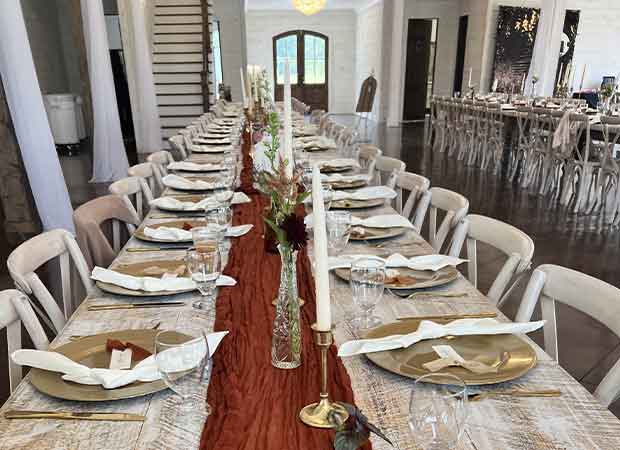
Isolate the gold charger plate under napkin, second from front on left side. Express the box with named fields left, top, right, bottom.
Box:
left=96, top=259, right=194, bottom=297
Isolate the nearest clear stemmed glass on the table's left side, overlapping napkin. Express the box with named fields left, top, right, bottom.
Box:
left=155, top=328, right=211, bottom=415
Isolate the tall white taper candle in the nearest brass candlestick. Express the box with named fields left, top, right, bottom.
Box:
left=312, top=164, right=332, bottom=331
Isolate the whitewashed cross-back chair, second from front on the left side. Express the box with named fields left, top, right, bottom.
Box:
left=6, top=229, right=94, bottom=332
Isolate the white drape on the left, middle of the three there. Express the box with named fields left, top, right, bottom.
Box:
left=81, top=0, right=129, bottom=182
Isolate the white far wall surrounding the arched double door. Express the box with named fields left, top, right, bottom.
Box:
left=245, top=10, right=357, bottom=113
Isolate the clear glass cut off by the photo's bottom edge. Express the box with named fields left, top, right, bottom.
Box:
left=409, top=373, right=467, bottom=450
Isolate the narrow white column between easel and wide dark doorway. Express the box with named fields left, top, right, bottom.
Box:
left=387, top=0, right=405, bottom=127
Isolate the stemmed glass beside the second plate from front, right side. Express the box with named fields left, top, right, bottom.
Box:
left=350, top=258, right=385, bottom=329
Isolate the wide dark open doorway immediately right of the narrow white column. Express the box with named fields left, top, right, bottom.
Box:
left=403, top=19, right=439, bottom=121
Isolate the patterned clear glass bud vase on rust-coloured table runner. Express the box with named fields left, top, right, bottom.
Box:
left=271, top=244, right=301, bottom=369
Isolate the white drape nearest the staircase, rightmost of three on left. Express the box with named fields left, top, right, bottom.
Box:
left=118, top=0, right=162, bottom=153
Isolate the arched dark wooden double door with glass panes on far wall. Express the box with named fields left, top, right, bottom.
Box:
left=273, top=30, right=329, bottom=111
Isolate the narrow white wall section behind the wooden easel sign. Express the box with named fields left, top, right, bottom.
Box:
left=355, top=2, right=385, bottom=121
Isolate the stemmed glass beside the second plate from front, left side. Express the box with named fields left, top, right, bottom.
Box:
left=186, top=241, right=222, bottom=310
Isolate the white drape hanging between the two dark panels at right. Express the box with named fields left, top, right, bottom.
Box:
left=525, top=0, right=566, bottom=96
